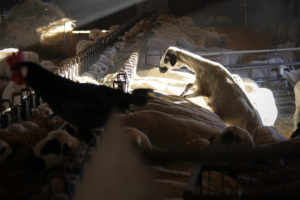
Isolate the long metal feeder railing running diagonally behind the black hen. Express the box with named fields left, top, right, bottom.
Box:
left=0, top=15, right=140, bottom=129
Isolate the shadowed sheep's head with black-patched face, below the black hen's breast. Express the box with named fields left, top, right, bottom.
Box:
left=33, top=130, right=80, bottom=168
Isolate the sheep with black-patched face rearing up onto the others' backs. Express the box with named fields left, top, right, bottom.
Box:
left=159, top=47, right=262, bottom=133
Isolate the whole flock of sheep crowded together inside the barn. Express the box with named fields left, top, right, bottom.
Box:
left=0, top=11, right=300, bottom=198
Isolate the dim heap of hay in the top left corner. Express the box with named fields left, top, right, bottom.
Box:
left=0, top=0, right=64, bottom=48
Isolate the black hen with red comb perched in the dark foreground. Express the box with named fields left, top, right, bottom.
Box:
left=6, top=51, right=151, bottom=140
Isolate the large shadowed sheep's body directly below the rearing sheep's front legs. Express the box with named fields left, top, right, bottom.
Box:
left=120, top=106, right=225, bottom=152
